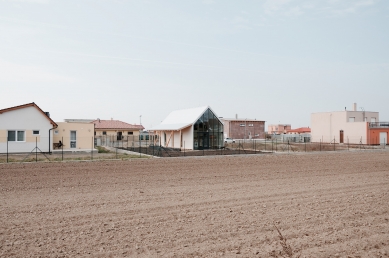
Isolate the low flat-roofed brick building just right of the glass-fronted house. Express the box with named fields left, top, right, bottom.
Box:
left=220, top=116, right=265, bottom=140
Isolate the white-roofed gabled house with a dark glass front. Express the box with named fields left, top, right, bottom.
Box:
left=150, top=106, right=224, bottom=150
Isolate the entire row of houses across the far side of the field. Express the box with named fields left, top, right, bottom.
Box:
left=0, top=103, right=389, bottom=153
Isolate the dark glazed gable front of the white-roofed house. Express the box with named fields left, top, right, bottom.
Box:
left=193, top=109, right=223, bottom=150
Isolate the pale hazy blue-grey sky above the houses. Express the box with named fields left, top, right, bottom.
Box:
left=0, top=0, right=389, bottom=128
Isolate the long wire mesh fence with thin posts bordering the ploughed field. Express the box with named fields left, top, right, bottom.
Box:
left=0, top=136, right=387, bottom=163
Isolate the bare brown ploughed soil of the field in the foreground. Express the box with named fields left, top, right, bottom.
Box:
left=0, top=151, right=389, bottom=257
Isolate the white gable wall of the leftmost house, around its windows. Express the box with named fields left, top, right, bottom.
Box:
left=0, top=107, right=53, bottom=153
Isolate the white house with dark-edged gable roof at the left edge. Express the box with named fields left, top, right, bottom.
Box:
left=0, top=102, right=57, bottom=153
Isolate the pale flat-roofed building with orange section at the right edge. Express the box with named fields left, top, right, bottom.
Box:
left=311, top=103, right=389, bottom=144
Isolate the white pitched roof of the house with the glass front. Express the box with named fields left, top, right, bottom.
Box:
left=150, top=106, right=216, bottom=131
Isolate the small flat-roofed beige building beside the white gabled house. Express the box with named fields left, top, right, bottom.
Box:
left=53, top=119, right=94, bottom=150
